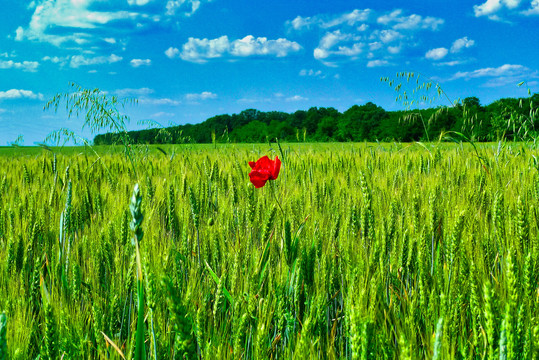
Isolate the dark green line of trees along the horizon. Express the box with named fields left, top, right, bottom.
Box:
left=94, top=93, right=539, bottom=145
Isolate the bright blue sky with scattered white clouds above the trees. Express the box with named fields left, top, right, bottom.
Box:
left=0, top=0, right=539, bottom=145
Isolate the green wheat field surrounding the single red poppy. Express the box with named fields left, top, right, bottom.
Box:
left=0, top=143, right=539, bottom=359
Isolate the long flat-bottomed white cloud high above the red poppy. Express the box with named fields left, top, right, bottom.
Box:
left=178, top=35, right=301, bottom=63
